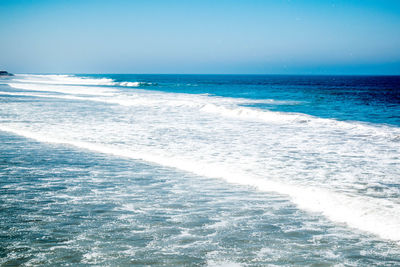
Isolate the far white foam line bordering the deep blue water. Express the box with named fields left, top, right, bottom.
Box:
left=3, top=83, right=400, bottom=140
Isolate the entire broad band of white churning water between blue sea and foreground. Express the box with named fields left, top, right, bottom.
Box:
left=0, top=76, right=400, bottom=244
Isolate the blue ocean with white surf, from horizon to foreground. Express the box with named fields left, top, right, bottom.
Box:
left=0, top=74, right=400, bottom=266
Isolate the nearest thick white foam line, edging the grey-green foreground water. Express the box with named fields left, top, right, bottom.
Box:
left=0, top=125, right=400, bottom=244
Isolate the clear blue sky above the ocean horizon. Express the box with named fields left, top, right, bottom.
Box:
left=0, top=0, right=400, bottom=75
